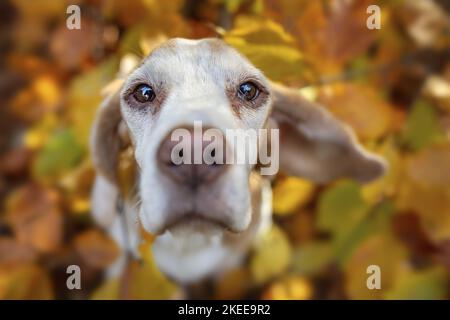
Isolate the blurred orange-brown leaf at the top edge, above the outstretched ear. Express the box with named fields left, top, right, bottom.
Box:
left=291, top=0, right=376, bottom=74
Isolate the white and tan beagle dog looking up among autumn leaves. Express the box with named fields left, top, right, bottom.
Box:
left=91, top=38, right=386, bottom=284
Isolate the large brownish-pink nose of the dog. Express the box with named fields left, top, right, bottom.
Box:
left=158, top=128, right=228, bottom=189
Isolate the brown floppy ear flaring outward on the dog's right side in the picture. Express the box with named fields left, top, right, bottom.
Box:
left=271, top=83, right=387, bottom=183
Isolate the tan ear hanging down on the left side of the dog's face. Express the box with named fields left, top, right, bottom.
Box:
left=90, top=90, right=129, bottom=184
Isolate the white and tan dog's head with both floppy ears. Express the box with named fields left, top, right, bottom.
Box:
left=92, top=39, right=385, bottom=270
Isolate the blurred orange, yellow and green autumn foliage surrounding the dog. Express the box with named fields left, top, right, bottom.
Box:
left=0, top=0, right=450, bottom=299
